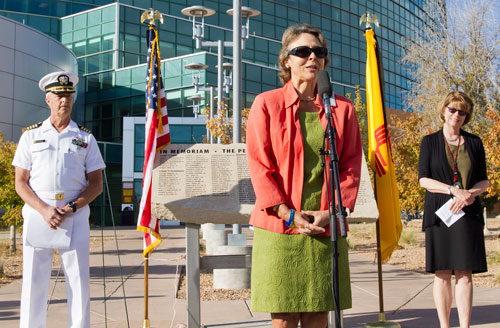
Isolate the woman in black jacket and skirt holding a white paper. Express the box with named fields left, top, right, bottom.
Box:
left=419, top=91, right=488, bottom=328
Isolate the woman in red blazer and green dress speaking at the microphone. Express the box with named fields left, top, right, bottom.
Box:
left=246, top=24, right=362, bottom=328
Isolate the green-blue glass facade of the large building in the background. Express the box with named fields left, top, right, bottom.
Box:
left=0, top=0, right=434, bottom=224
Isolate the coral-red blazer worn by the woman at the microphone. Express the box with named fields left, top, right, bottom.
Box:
left=246, top=81, right=363, bottom=236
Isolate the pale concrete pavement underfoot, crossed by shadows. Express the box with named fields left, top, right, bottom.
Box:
left=0, top=227, right=500, bottom=328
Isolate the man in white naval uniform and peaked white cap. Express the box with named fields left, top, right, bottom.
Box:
left=12, top=72, right=105, bottom=328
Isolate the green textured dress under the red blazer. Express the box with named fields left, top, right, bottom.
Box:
left=251, top=112, right=352, bottom=313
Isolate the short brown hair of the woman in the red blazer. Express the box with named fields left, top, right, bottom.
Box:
left=278, top=24, right=330, bottom=84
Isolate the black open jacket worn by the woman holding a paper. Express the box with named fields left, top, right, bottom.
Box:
left=418, top=130, right=488, bottom=229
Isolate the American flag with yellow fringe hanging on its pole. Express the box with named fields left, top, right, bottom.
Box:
left=137, top=25, right=170, bottom=257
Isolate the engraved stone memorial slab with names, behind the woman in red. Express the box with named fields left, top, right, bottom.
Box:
left=151, top=144, right=378, bottom=224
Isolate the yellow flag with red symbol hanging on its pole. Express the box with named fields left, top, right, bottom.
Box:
left=365, top=29, right=402, bottom=262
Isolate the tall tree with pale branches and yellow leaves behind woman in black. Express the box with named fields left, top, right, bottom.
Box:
left=402, top=0, right=500, bottom=209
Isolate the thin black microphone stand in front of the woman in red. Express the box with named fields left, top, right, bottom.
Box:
left=319, top=94, right=347, bottom=328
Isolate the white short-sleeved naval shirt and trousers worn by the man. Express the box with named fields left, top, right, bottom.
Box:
left=12, top=118, right=105, bottom=328
